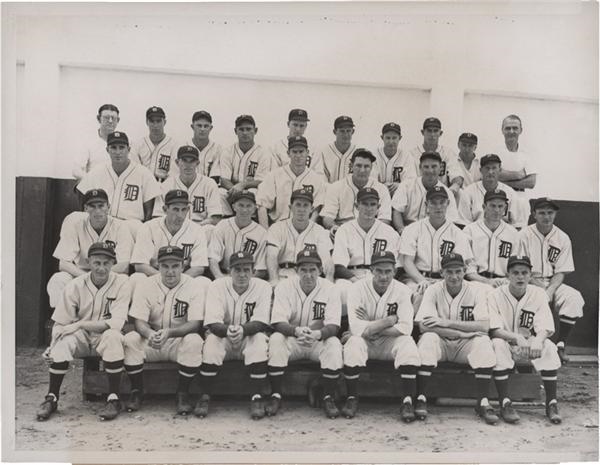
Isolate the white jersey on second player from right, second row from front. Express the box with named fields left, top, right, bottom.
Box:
left=463, top=218, right=520, bottom=276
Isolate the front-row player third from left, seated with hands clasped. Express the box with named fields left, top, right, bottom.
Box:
left=194, top=252, right=272, bottom=420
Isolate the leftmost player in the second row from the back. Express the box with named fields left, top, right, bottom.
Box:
left=77, top=132, right=160, bottom=238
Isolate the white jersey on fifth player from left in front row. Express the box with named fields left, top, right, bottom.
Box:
left=348, top=278, right=414, bottom=336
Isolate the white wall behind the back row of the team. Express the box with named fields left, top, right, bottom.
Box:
left=3, top=2, right=598, bottom=200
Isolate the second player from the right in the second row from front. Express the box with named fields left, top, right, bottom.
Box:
left=463, top=189, right=519, bottom=287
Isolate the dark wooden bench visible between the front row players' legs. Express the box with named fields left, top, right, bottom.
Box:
left=83, top=357, right=541, bottom=406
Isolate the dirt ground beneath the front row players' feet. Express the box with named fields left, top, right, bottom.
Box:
left=15, top=349, right=598, bottom=461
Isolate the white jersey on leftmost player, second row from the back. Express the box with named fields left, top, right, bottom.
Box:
left=77, top=162, right=160, bottom=221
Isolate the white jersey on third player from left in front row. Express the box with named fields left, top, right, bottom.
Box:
left=204, top=277, right=272, bottom=325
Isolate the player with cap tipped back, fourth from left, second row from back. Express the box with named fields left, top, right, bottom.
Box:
left=321, top=149, right=391, bottom=230
